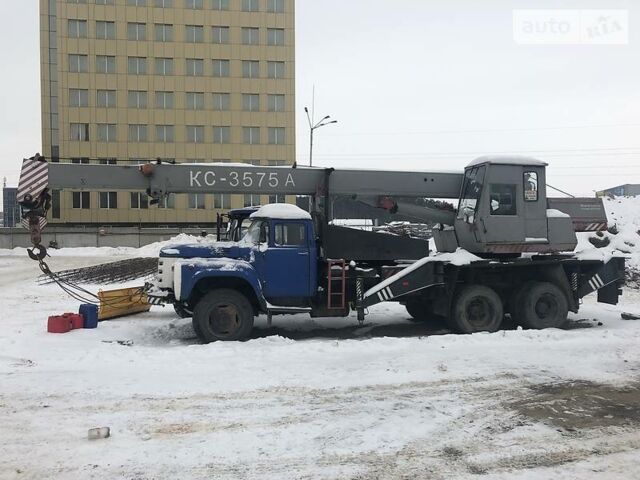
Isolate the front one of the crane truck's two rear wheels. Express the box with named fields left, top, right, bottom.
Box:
left=449, top=285, right=504, bottom=333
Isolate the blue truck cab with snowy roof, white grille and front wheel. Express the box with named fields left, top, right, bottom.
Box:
left=149, top=204, right=318, bottom=342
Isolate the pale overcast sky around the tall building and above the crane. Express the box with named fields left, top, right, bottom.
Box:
left=0, top=0, right=640, bottom=201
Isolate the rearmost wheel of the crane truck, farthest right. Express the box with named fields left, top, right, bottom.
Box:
left=515, top=282, right=569, bottom=329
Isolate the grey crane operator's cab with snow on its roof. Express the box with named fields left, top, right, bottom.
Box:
left=434, top=157, right=577, bottom=254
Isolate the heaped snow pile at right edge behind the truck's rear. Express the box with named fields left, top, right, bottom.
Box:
left=575, top=197, right=640, bottom=271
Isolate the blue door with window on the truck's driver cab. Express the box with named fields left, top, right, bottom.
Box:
left=264, top=220, right=316, bottom=298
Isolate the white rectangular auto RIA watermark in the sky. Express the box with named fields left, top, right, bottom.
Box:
left=513, top=10, right=629, bottom=45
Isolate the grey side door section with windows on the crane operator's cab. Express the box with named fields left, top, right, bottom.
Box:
left=478, top=164, right=548, bottom=248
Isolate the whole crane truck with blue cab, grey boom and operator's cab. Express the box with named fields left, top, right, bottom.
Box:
left=17, top=156, right=625, bottom=342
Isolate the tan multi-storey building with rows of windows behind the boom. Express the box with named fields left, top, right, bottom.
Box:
left=40, top=0, right=295, bottom=225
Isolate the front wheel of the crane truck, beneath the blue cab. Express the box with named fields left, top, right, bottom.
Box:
left=193, top=289, right=253, bottom=343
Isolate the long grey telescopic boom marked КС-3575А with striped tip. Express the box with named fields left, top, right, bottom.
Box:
left=17, top=155, right=463, bottom=255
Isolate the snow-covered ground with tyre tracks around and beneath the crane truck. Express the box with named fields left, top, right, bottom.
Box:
left=0, top=199, right=640, bottom=480
